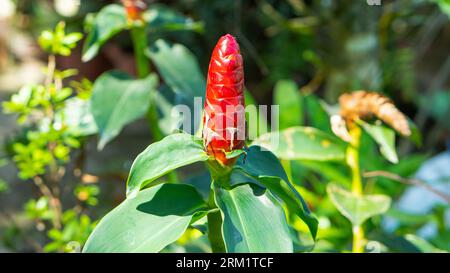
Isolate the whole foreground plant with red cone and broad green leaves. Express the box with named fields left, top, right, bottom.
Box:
left=83, top=34, right=317, bottom=253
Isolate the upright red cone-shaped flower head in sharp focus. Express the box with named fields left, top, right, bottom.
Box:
left=203, top=34, right=245, bottom=165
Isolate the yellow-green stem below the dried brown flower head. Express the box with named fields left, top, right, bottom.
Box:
left=346, top=126, right=364, bottom=253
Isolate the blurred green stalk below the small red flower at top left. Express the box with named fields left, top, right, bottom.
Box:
left=131, top=23, right=179, bottom=183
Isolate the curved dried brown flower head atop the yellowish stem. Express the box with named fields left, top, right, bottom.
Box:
left=339, top=91, right=411, bottom=136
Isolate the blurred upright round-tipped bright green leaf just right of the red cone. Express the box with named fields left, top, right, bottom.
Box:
left=274, top=80, right=303, bottom=130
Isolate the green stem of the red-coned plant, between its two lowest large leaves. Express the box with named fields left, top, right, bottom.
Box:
left=207, top=184, right=226, bottom=253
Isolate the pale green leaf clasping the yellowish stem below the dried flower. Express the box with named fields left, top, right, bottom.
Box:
left=327, top=183, right=391, bottom=226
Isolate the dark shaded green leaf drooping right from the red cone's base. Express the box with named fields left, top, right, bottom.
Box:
left=233, top=146, right=317, bottom=238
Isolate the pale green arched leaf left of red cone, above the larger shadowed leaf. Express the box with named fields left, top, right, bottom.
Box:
left=127, top=133, right=208, bottom=198
